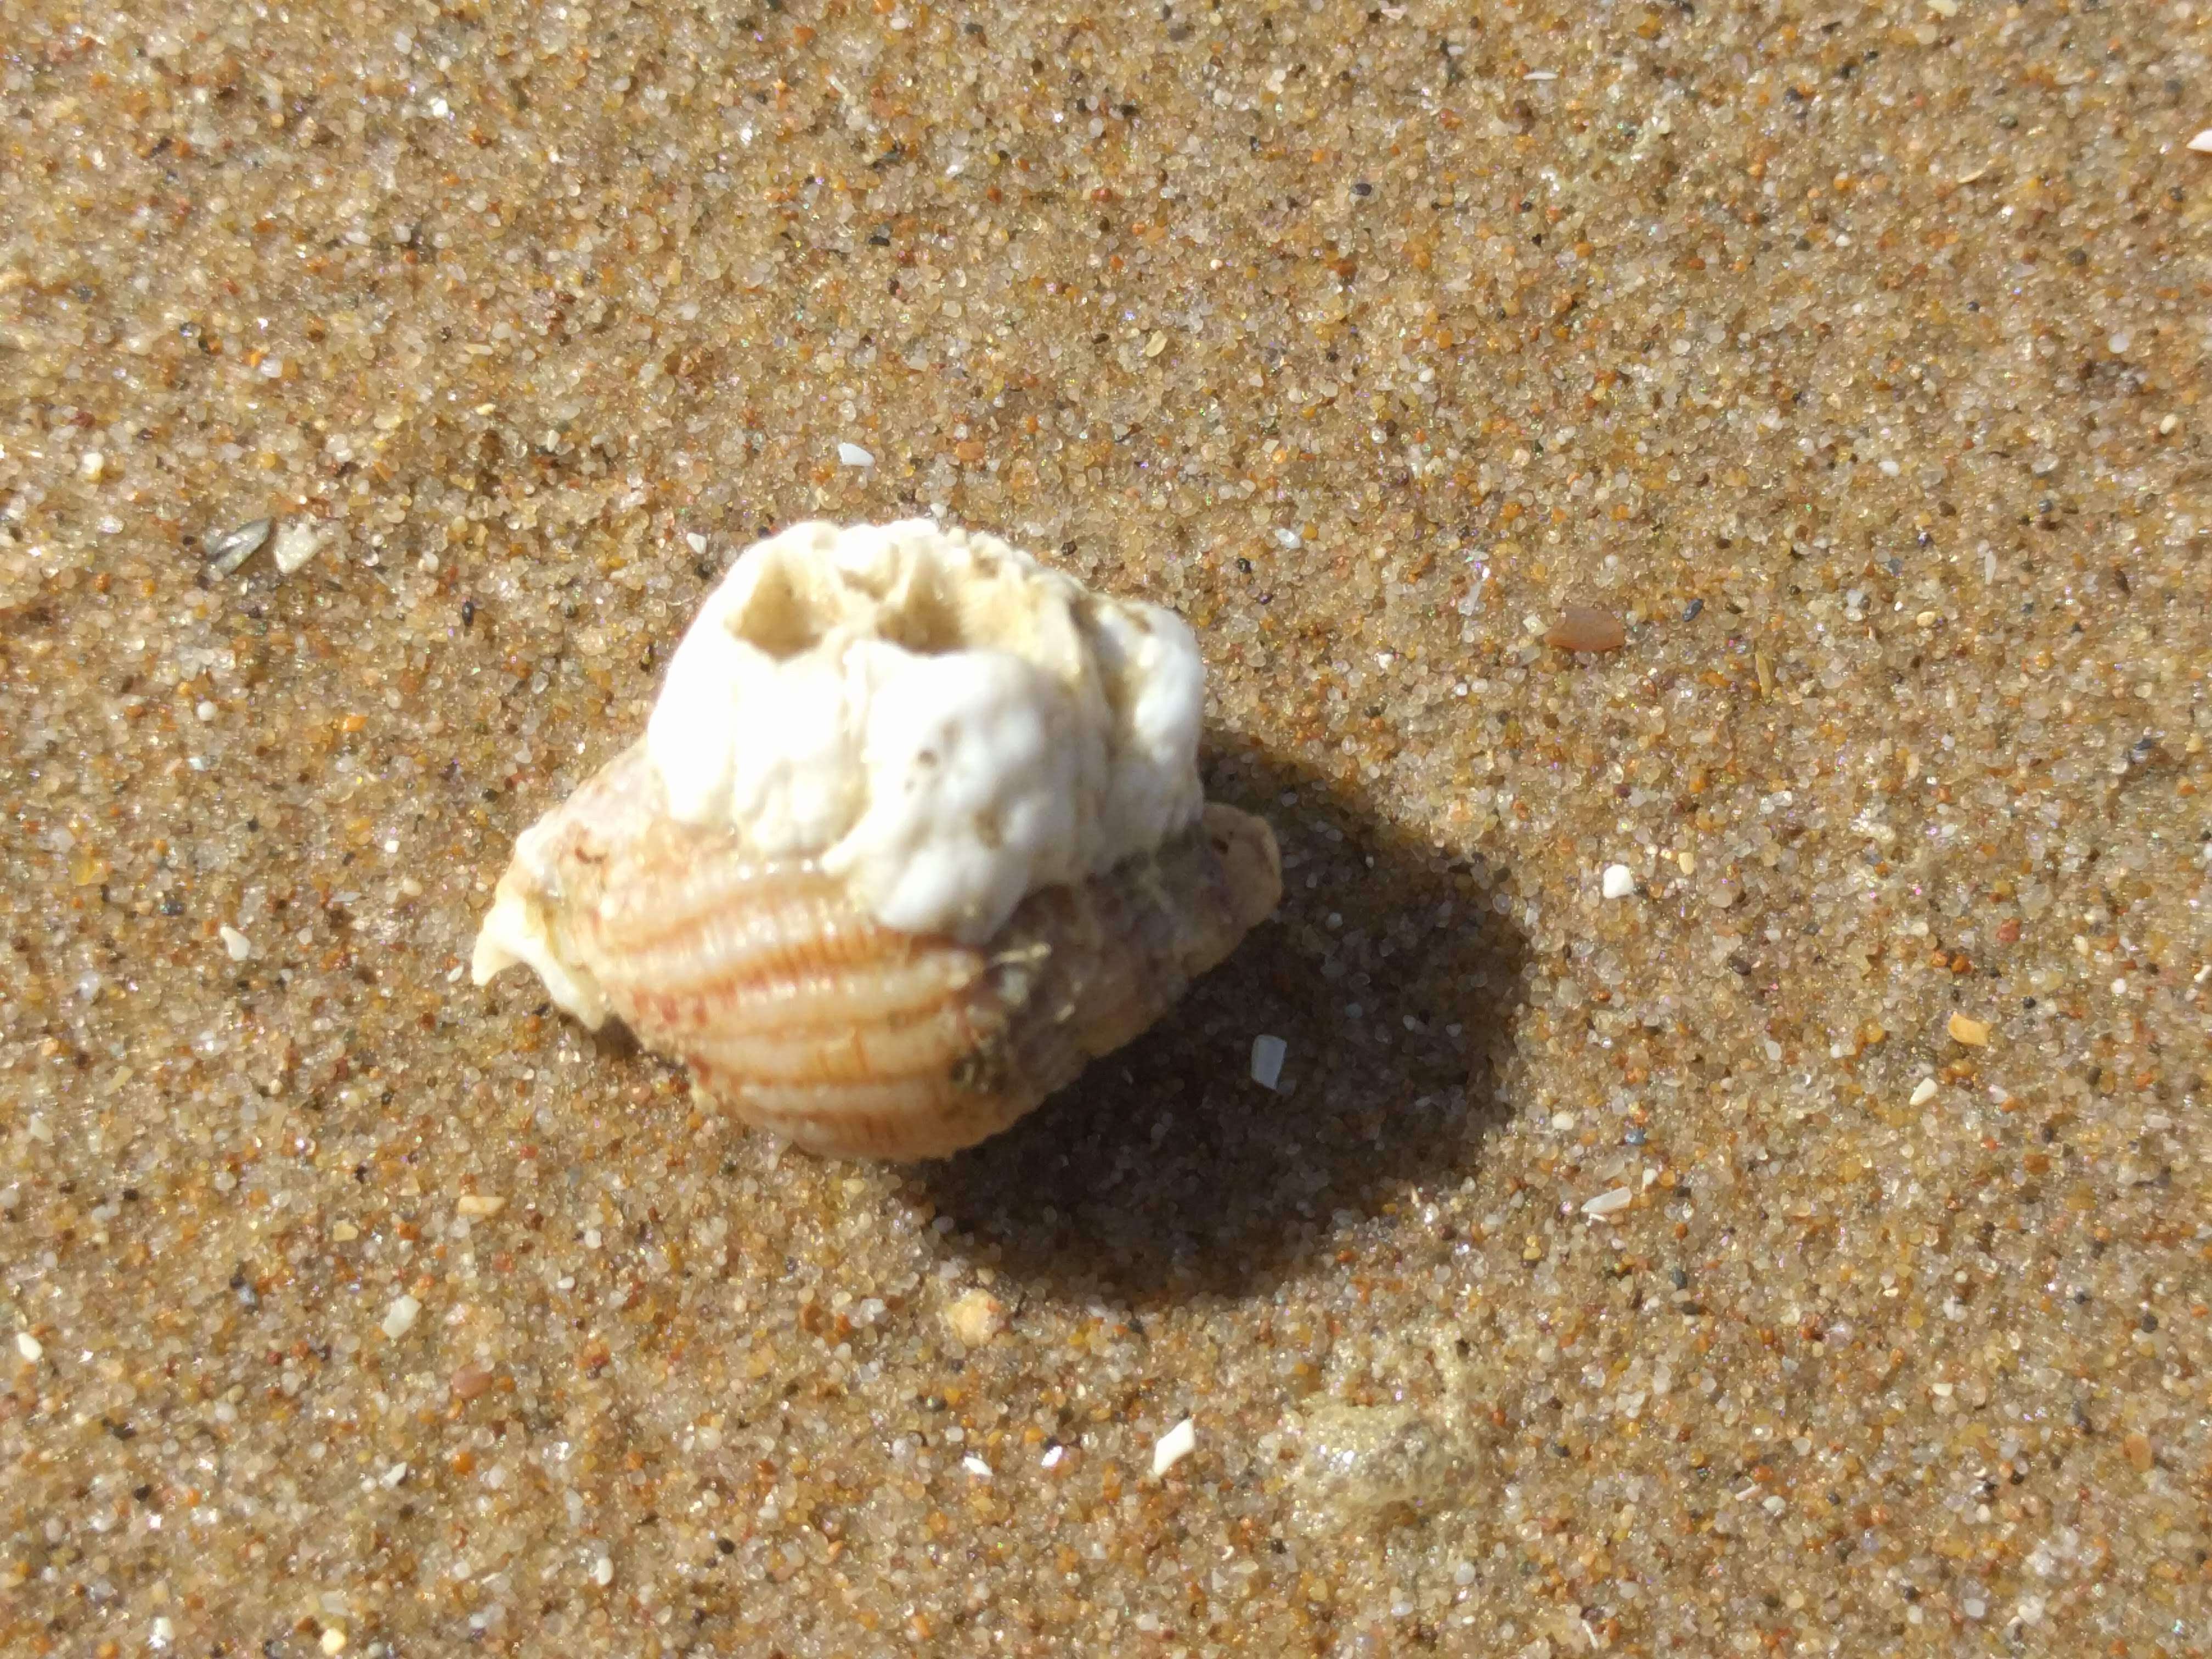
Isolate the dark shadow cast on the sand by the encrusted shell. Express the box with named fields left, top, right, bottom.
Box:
left=907, top=732, right=1526, bottom=1305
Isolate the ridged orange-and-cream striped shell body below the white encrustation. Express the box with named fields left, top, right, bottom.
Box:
left=478, top=746, right=1283, bottom=1159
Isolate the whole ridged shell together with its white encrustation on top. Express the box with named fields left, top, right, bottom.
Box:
left=473, top=520, right=1283, bottom=1159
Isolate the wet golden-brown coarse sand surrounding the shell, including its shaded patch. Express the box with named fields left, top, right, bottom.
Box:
left=0, top=0, right=2212, bottom=1659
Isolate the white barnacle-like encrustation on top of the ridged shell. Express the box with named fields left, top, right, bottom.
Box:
left=646, top=517, right=1205, bottom=945
